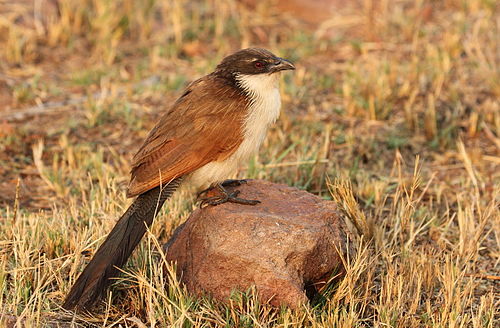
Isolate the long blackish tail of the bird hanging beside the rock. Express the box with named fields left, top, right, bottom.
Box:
left=63, top=178, right=181, bottom=310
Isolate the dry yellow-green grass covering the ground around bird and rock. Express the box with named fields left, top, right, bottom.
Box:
left=0, top=0, right=500, bottom=327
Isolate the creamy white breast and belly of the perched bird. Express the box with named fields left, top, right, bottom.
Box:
left=189, top=73, right=281, bottom=189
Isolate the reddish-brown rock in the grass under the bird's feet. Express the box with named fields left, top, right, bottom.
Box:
left=165, top=180, right=346, bottom=308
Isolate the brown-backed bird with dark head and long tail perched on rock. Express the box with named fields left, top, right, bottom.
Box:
left=62, top=48, right=295, bottom=311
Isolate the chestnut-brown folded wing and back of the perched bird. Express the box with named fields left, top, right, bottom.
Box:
left=127, top=75, right=248, bottom=197
